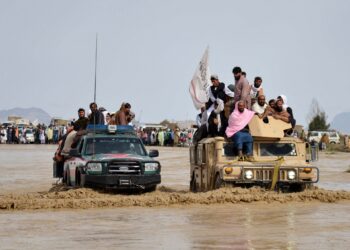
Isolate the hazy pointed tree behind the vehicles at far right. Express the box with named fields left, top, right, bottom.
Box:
left=309, top=99, right=330, bottom=131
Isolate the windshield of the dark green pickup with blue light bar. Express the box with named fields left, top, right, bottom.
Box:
left=85, top=137, right=146, bottom=156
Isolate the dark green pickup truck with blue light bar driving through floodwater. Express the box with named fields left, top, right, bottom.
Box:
left=54, top=125, right=161, bottom=191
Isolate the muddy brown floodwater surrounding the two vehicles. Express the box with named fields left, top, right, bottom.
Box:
left=0, top=145, right=350, bottom=249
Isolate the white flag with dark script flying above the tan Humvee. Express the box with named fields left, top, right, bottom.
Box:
left=190, top=48, right=210, bottom=109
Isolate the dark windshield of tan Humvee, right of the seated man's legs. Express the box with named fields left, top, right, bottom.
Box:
left=260, top=143, right=297, bottom=156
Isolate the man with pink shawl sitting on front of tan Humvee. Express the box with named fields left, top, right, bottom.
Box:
left=226, top=100, right=255, bottom=158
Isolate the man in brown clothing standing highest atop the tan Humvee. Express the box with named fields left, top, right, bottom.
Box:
left=232, top=67, right=251, bottom=109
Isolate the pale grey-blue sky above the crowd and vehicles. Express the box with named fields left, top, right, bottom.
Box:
left=0, top=0, right=350, bottom=125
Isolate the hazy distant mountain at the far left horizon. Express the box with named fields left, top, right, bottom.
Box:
left=0, top=108, right=51, bottom=124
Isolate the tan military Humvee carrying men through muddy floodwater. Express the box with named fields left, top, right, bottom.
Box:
left=190, top=116, right=319, bottom=192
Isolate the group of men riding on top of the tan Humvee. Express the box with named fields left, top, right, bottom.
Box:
left=193, top=67, right=296, bottom=158
